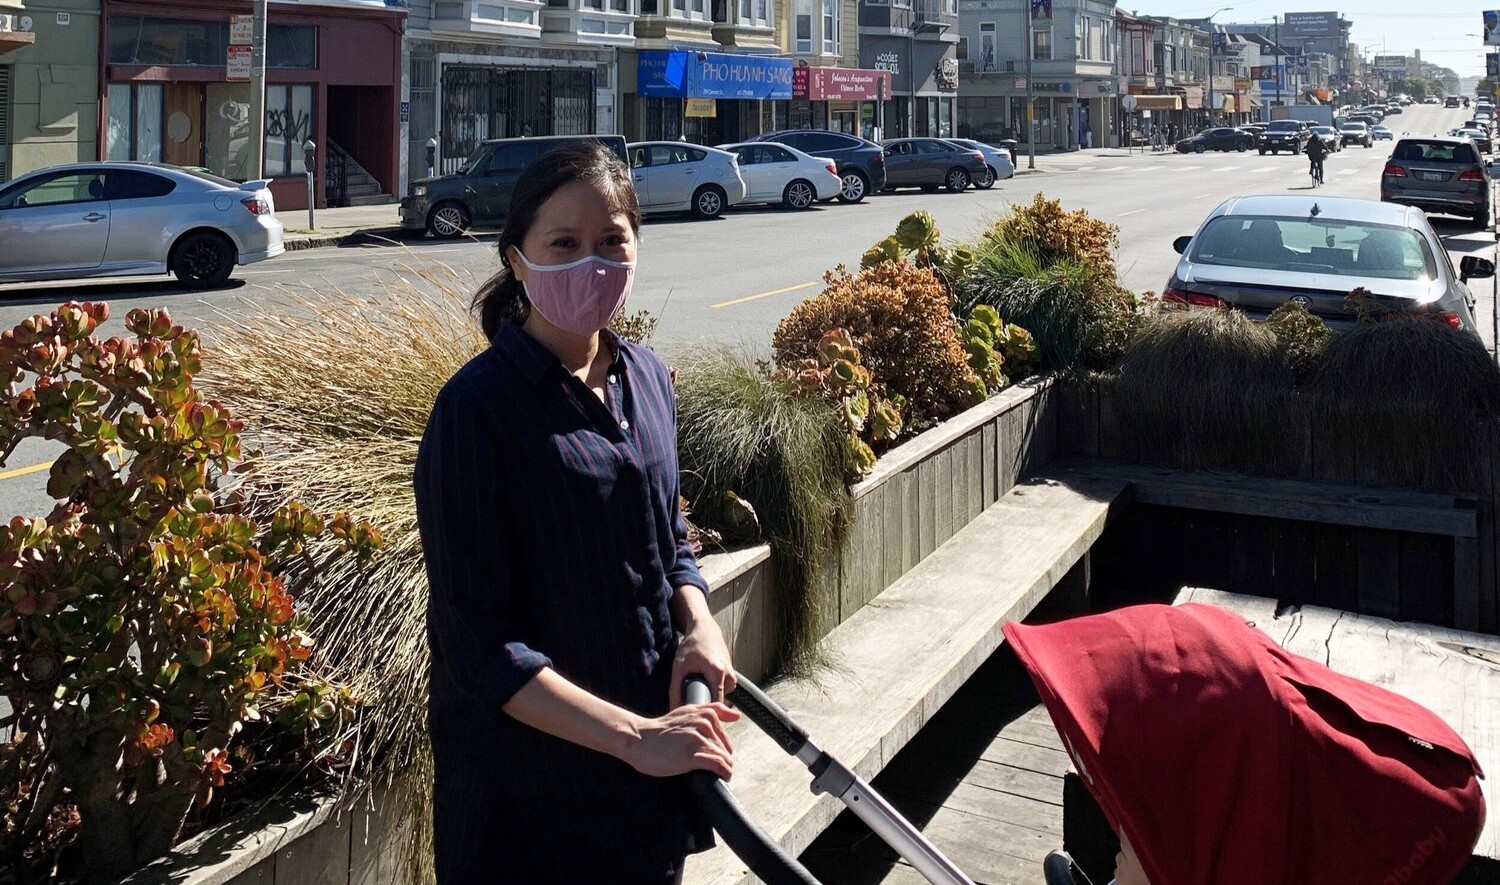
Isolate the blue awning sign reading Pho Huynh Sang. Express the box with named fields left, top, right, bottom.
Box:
left=636, top=50, right=792, bottom=99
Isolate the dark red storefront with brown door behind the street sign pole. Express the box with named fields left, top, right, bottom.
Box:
left=99, top=0, right=405, bottom=209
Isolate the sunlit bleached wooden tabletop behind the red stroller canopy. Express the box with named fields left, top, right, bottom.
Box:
left=1179, top=590, right=1500, bottom=860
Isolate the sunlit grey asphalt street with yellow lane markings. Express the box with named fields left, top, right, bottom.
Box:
left=0, top=107, right=1496, bottom=515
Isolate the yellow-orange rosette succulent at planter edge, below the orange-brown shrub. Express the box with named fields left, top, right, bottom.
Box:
left=776, top=329, right=903, bottom=474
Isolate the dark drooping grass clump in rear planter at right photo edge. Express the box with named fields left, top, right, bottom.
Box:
left=1307, top=314, right=1500, bottom=492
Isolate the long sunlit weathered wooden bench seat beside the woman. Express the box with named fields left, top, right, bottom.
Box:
left=684, top=471, right=1128, bottom=885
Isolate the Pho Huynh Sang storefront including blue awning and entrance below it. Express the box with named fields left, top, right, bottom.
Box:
left=627, top=50, right=792, bottom=144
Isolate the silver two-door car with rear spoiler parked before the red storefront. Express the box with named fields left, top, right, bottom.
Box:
left=0, top=162, right=285, bottom=288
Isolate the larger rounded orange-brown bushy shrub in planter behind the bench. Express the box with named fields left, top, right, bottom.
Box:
left=771, top=261, right=986, bottom=431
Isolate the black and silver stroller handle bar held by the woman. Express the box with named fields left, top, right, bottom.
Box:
left=683, top=674, right=974, bottom=885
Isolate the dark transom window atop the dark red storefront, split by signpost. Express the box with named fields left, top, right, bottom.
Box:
left=108, top=15, right=318, bottom=69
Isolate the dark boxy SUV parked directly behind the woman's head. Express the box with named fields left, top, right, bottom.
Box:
left=401, top=135, right=630, bottom=239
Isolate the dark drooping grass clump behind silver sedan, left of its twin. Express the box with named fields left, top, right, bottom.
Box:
left=1113, top=311, right=1305, bottom=474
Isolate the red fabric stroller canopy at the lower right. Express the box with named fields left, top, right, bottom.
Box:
left=1005, top=605, right=1485, bottom=885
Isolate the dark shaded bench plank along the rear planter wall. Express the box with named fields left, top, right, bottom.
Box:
left=1053, top=459, right=1478, bottom=537
